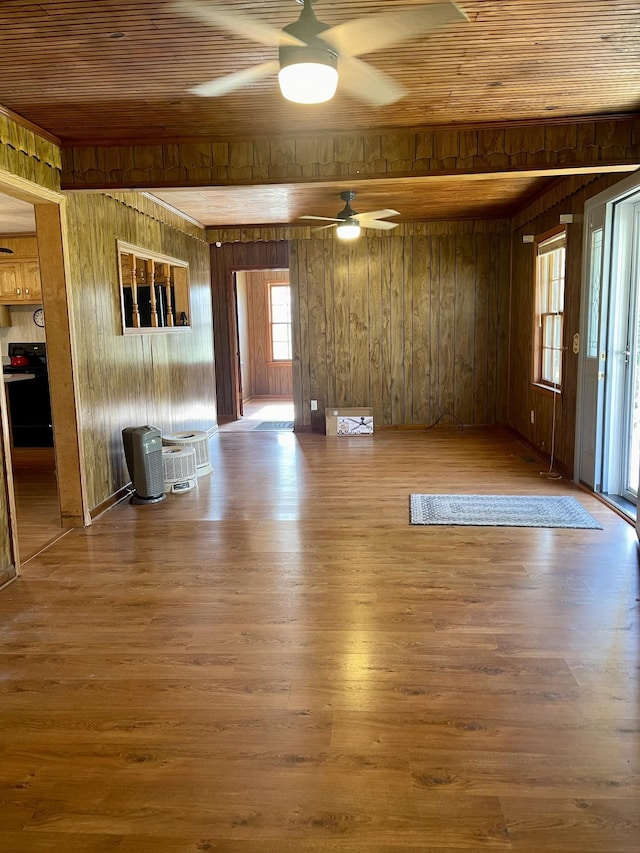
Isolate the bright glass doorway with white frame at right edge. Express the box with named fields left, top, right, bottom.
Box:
left=576, top=178, right=640, bottom=519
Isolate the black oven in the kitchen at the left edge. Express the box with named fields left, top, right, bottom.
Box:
left=3, top=341, right=53, bottom=447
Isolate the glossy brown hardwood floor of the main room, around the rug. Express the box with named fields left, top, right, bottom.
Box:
left=0, top=428, right=640, bottom=853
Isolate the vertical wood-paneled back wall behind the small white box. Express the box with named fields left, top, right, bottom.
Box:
left=295, top=223, right=509, bottom=426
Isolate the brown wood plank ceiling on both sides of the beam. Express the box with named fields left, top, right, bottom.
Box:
left=0, top=0, right=640, bottom=226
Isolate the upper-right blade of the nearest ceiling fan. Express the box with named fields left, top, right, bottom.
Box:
left=322, top=2, right=469, bottom=57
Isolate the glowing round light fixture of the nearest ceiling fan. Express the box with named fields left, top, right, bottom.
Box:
left=278, top=46, right=338, bottom=104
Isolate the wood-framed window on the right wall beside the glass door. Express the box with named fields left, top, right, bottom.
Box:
left=533, top=228, right=566, bottom=390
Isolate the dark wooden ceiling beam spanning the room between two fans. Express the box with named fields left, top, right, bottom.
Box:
left=62, top=117, right=640, bottom=190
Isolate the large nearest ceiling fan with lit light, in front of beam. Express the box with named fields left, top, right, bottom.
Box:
left=177, top=0, right=468, bottom=105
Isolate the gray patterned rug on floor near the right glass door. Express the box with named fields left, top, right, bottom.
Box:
left=410, top=495, right=602, bottom=530
